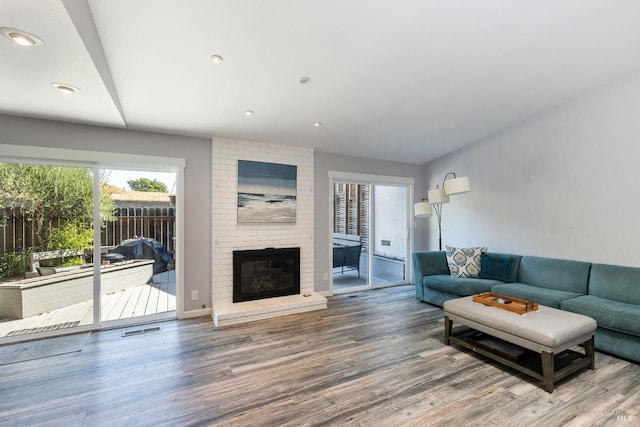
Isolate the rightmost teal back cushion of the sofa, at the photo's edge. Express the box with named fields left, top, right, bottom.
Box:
left=588, top=264, right=640, bottom=304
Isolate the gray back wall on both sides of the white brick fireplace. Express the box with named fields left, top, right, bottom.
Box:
left=0, top=115, right=427, bottom=311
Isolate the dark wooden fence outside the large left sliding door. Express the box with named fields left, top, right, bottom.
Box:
left=0, top=208, right=176, bottom=255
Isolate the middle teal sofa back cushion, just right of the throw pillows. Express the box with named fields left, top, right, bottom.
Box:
left=517, top=256, right=591, bottom=296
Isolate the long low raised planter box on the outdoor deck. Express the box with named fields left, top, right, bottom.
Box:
left=0, top=260, right=153, bottom=319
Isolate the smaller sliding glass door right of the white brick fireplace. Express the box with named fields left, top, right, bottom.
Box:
left=330, top=173, right=413, bottom=293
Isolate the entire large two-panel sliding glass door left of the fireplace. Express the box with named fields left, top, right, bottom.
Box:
left=0, top=155, right=179, bottom=343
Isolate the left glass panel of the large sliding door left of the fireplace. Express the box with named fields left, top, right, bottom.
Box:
left=0, top=162, right=100, bottom=338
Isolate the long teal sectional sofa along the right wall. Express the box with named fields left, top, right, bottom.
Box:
left=412, top=251, right=640, bottom=362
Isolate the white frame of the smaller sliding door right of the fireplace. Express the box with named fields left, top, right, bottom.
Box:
left=327, top=170, right=415, bottom=295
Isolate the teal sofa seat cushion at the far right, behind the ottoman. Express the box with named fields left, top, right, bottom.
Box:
left=561, top=295, right=640, bottom=336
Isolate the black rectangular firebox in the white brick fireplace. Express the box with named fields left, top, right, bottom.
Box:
left=233, top=248, right=300, bottom=302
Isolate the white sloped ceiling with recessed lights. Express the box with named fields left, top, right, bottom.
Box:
left=0, top=0, right=640, bottom=164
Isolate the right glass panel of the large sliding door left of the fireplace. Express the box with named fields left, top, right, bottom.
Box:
left=100, top=169, right=176, bottom=324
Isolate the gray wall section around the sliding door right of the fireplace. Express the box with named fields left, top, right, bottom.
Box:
left=314, top=152, right=426, bottom=292
